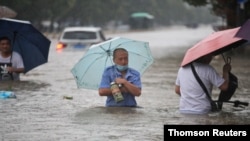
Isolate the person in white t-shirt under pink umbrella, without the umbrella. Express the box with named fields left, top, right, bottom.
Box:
left=175, top=53, right=231, bottom=114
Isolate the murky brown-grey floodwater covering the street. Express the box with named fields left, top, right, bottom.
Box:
left=0, top=26, right=250, bottom=141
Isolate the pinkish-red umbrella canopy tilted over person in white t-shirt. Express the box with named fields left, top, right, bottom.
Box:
left=181, top=27, right=246, bottom=66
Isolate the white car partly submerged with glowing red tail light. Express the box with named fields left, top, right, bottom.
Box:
left=56, top=27, right=106, bottom=49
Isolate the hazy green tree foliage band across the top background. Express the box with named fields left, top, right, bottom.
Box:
left=0, top=0, right=219, bottom=30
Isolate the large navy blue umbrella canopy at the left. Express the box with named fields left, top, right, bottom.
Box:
left=0, top=18, right=50, bottom=73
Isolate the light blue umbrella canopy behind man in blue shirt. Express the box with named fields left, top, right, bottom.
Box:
left=71, top=37, right=154, bottom=90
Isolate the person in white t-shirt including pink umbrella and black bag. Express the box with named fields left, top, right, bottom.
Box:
left=175, top=27, right=246, bottom=114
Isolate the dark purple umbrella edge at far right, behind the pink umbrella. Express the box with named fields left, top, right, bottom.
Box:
left=235, top=19, right=250, bottom=41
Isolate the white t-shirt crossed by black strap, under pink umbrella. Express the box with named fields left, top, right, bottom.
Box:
left=175, top=63, right=225, bottom=114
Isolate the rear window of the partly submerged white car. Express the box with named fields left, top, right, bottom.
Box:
left=63, top=31, right=97, bottom=39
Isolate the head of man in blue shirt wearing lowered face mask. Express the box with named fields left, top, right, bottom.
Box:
left=113, top=48, right=128, bottom=71
